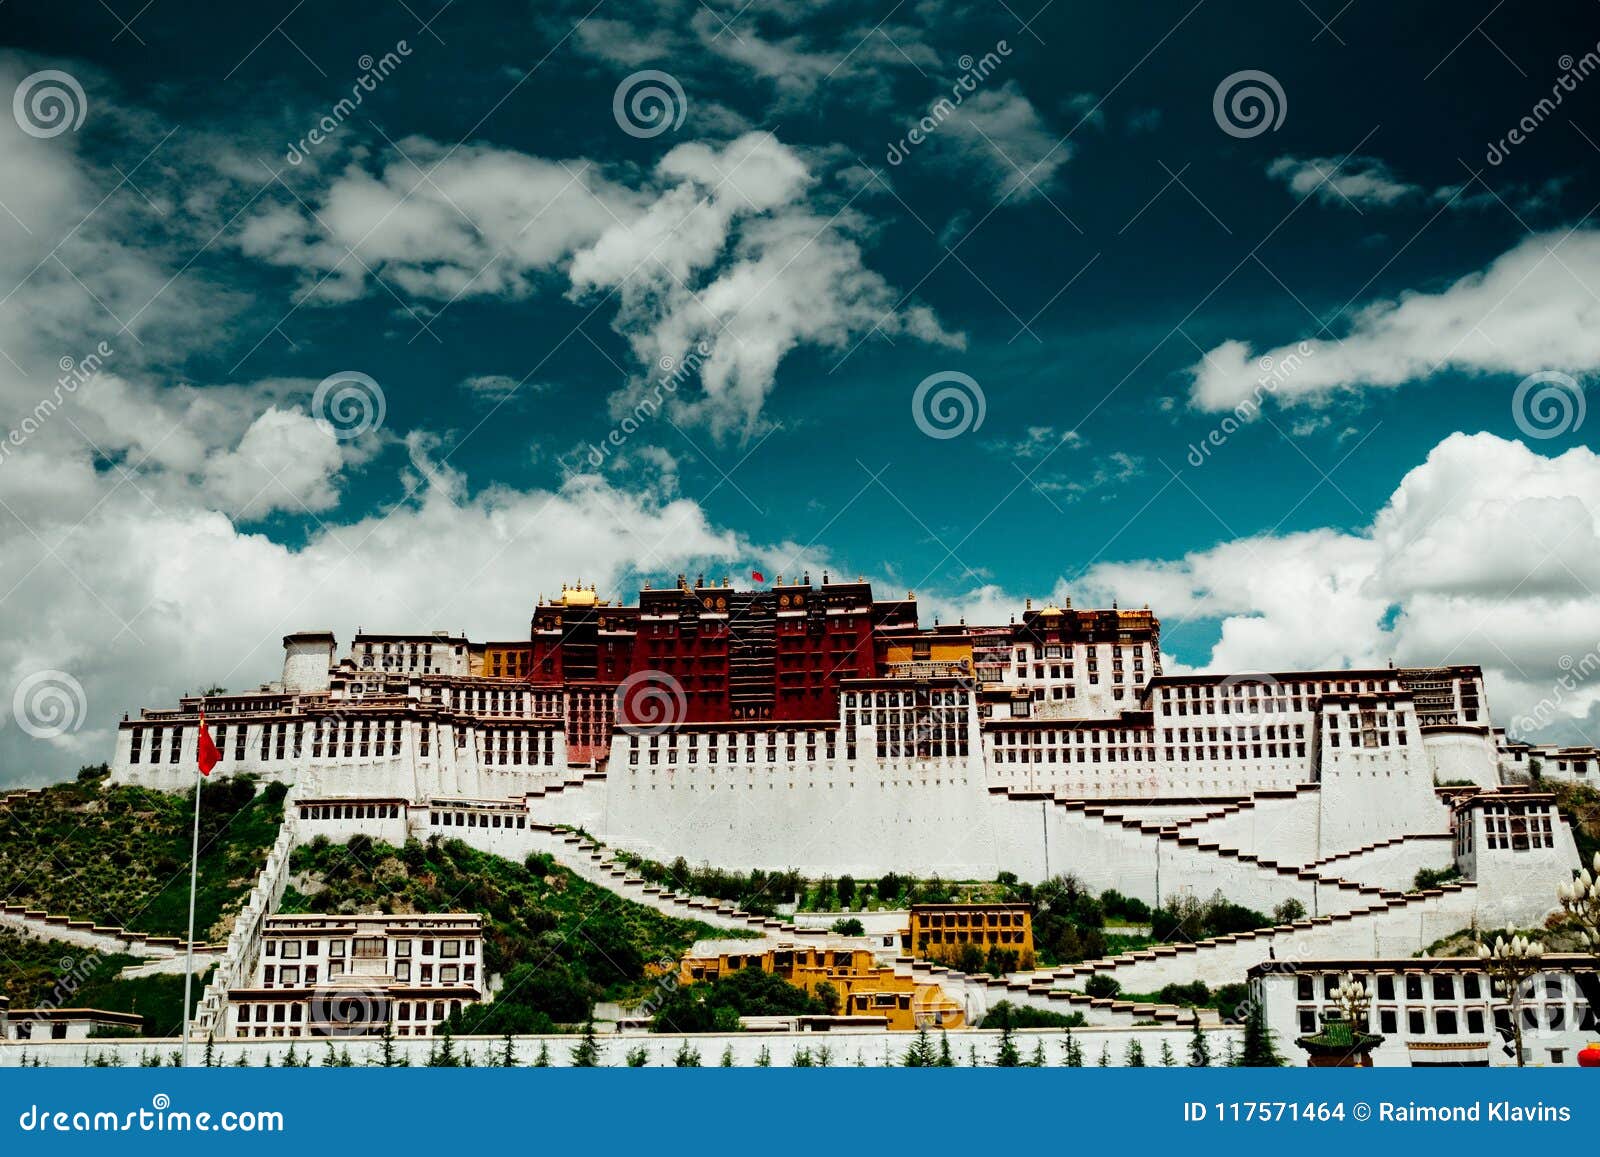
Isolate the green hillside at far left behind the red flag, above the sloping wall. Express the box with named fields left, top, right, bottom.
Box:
left=0, top=768, right=286, bottom=941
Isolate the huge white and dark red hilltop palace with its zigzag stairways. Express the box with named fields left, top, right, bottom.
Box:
left=81, top=576, right=1592, bottom=1063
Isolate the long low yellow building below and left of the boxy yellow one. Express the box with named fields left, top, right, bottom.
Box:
left=678, top=946, right=966, bottom=1031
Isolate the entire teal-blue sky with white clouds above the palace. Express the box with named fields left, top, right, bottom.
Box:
left=0, top=0, right=1600, bottom=779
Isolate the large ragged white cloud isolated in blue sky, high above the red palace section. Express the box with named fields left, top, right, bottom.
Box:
left=238, top=133, right=960, bottom=435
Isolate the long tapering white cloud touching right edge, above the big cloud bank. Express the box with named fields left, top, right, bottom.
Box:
left=1189, top=229, right=1600, bottom=411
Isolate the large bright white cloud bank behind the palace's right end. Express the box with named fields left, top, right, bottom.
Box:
left=1072, top=434, right=1600, bottom=741
